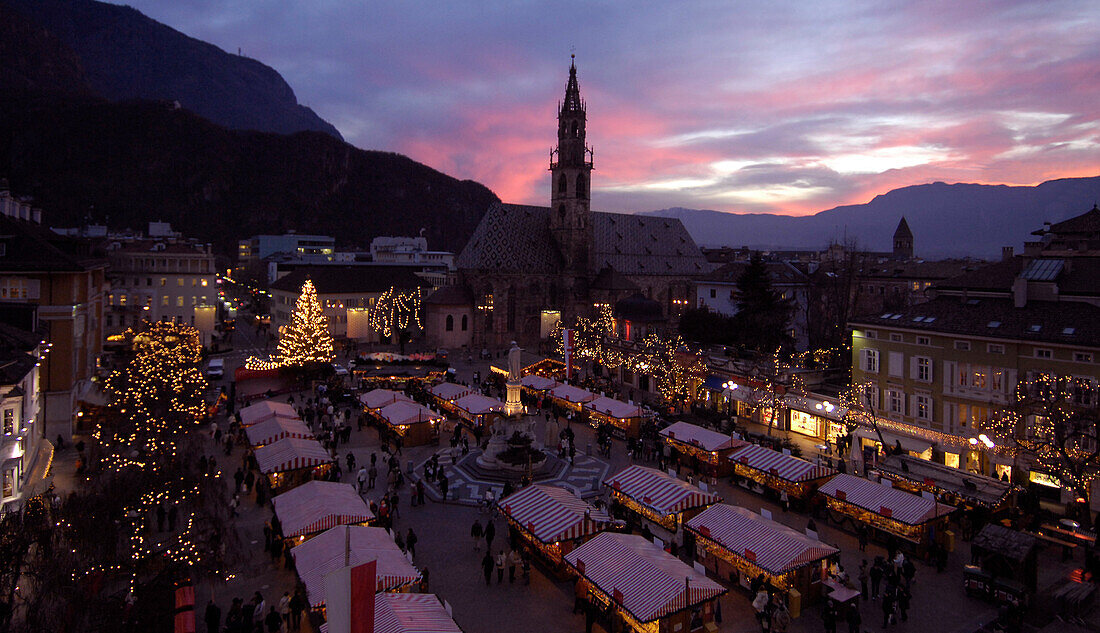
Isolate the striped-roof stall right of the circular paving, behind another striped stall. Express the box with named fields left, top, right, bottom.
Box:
left=604, top=466, right=722, bottom=538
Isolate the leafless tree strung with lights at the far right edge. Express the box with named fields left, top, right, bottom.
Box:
left=987, top=374, right=1100, bottom=508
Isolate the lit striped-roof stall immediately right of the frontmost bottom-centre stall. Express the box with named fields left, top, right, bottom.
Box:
left=684, top=503, right=840, bottom=607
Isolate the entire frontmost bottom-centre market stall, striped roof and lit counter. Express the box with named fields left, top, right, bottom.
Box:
left=565, top=532, right=727, bottom=633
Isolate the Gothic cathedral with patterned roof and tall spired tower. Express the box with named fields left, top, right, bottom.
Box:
left=425, top=63, right=711, bottom=348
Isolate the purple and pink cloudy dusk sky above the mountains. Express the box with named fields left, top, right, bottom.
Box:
left=122, top=0, right=1100, bottom=214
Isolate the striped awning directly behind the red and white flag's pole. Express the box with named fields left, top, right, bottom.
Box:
left=290, top=525, right=420, bottom=607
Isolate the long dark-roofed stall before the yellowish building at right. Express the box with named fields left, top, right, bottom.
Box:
left=877, top=455, right=1013, bottom=512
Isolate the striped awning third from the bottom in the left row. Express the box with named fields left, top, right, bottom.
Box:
left=272, top=481, right=374, bottom=537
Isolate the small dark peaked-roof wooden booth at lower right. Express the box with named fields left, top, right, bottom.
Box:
left=963, top=523, right=1038, bottom=607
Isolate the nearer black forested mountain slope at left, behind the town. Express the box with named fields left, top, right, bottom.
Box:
left=0, top=3, right=497, bottom=254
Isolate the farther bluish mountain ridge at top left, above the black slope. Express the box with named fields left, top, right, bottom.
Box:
left=2, top=0, right=340, bottom=139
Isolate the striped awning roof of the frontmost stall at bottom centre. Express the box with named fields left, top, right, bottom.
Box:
left=565, top=532, right=726, bottom=622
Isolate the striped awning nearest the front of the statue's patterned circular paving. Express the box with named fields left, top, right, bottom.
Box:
left=499, top=484, right=612, bottom=543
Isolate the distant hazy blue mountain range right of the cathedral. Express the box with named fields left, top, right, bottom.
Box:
left=646, top=176, right=1100, bottom=258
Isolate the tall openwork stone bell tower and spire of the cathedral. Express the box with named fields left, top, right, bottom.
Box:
left=550, top=62, right=592, bottom=275
